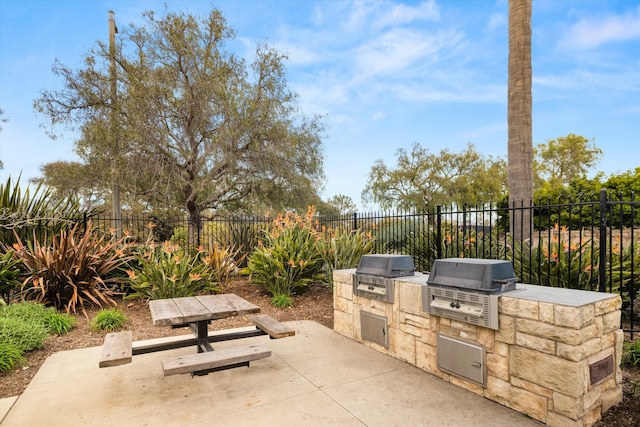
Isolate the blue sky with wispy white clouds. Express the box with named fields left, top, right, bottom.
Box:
left=0, top=0, right=640, bottom=209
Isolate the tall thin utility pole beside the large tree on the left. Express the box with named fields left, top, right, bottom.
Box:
left=109, top=10, right=122, bottom=239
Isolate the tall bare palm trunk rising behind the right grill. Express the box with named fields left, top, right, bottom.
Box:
left=507, top=0, right=533, bottom=242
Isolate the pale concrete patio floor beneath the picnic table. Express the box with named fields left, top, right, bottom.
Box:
left=0, top=321, right=541, bottom=427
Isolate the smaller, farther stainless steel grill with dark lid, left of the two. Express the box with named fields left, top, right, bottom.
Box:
left=353, top=254, right=415, bottom=304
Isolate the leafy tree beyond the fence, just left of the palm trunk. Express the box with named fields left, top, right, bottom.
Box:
left=362, top=143, right=506, bottom=209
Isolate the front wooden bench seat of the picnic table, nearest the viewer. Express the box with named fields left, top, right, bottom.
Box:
left=162, top=344, right=271, bottom=376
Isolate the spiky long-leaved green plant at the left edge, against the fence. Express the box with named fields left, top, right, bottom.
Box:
left=0, top=177, right=84, bottom=247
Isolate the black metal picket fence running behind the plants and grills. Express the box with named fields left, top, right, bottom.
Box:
left=84, top=190, right=640, bottom=332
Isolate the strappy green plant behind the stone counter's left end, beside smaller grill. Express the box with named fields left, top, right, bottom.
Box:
left=318, top=230, right=373, bottom=289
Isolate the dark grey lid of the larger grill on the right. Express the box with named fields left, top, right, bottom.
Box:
left=427, top=258, right=518, bottom=292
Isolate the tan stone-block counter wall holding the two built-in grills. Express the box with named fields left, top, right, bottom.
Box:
left=334, top=269, right=624, bottom=426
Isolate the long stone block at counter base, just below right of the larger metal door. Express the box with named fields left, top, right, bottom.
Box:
left=484, top=376, right=547, bottom=423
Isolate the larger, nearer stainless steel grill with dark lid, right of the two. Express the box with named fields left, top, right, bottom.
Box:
left=422, top=258, right=517, bottom=330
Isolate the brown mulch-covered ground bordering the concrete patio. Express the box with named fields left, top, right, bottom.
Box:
left=0, top=278, right=640, bottom=427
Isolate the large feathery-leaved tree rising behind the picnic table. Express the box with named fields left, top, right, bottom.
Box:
left=34, top=9, right=323, bottom=237
